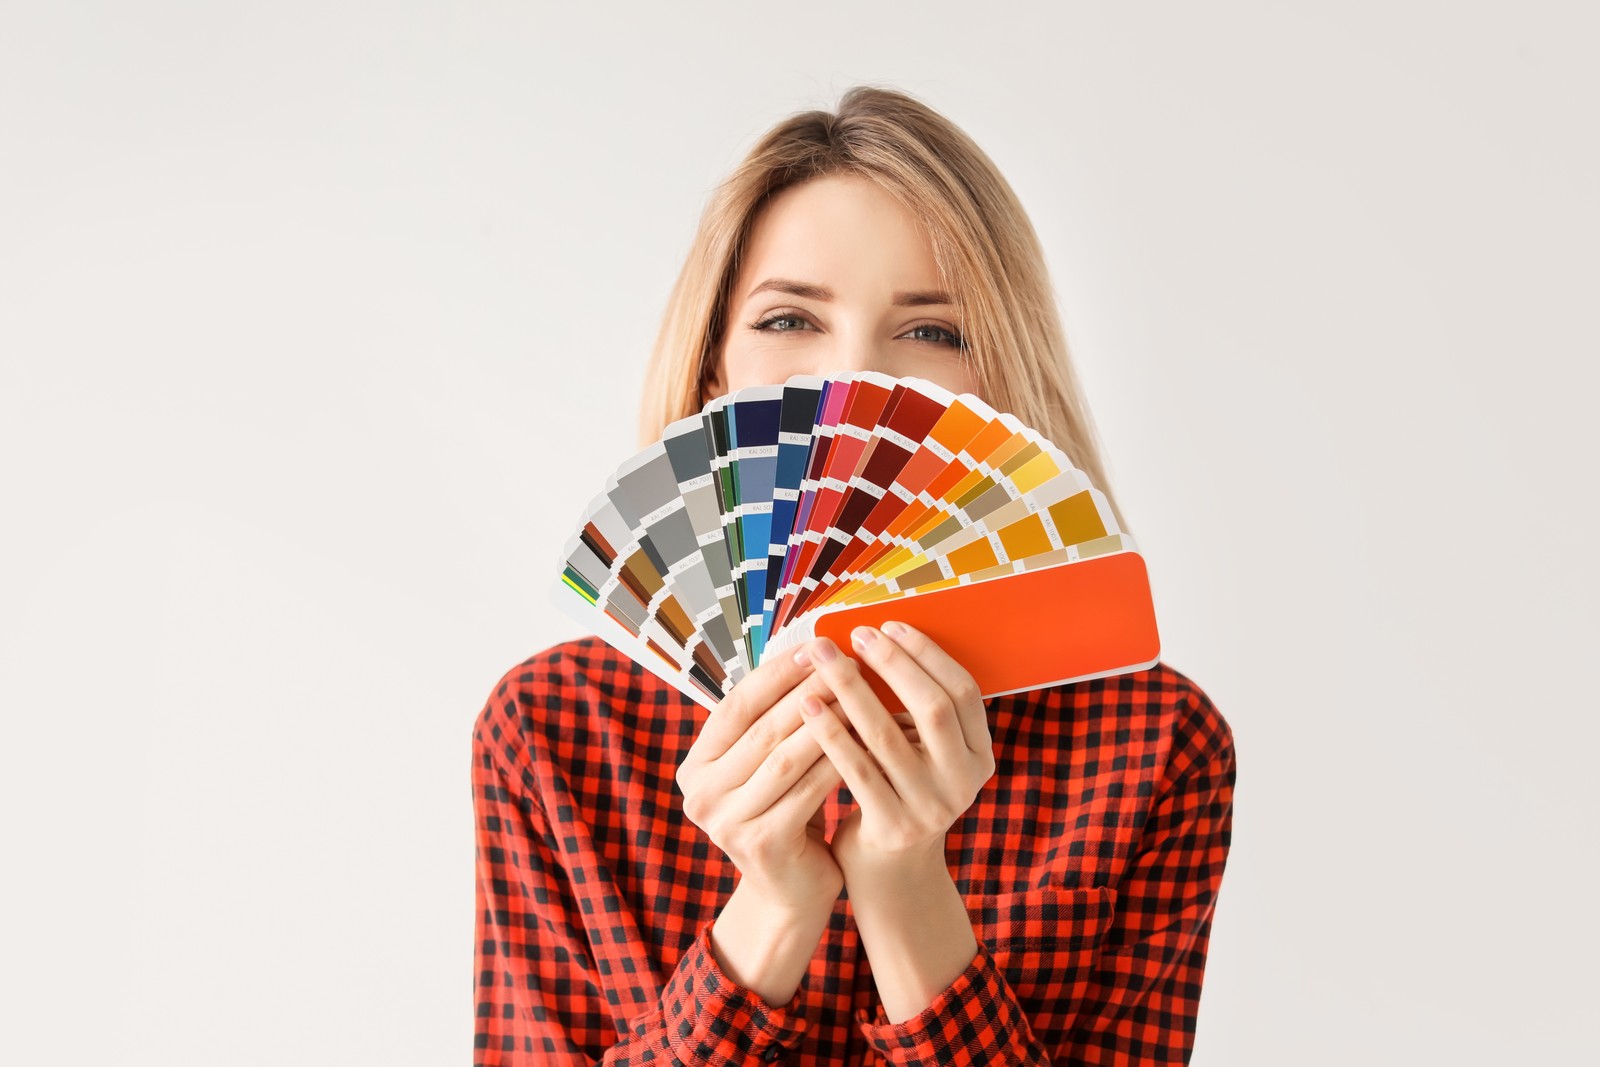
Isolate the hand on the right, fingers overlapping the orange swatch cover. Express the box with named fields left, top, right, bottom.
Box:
left=802, top=622, right=995, bottom=885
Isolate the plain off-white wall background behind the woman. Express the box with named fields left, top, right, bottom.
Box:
left=0, top=0, right=1600, bottom=1067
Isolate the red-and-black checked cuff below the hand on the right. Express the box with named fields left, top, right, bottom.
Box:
left=856, top=941, right=1034, bottom=1065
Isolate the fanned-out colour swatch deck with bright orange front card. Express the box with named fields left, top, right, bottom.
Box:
left=554, top=373, right=1160, bottom=707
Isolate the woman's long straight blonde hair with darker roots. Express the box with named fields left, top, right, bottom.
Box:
left=638, top=85, right=1128, bottom=530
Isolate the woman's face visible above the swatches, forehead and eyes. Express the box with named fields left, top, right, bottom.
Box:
left=702, top=176, right=978, bottom=400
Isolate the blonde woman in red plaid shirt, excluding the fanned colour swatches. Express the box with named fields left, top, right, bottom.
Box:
left=472, top=86, right=1234, bottom=1064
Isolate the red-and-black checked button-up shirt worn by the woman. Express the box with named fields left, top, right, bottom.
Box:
left=472, top=638, right=1234, bottom=1065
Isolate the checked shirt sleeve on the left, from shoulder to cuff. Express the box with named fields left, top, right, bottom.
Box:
left=472, top=703, right=806, bottom=1067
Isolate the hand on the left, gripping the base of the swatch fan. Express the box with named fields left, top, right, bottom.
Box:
left=677, top=653, right=845, bottom=917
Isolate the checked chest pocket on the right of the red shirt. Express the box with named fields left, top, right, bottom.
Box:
left=968, top=886, right=1117, bottom=1023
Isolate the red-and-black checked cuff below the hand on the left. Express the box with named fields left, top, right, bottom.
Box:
left=661, top=921, right=806, bottom=1064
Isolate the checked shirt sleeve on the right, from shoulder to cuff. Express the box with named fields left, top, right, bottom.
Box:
left=856, top=691, right=1235, bottom=1067
